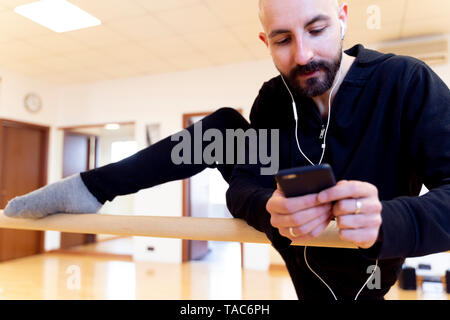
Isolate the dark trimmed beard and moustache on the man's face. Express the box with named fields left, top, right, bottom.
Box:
left=281, top=49, right=342, bottom=98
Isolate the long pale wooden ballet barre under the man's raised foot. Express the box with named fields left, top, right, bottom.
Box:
left=0, top=211, right=357, bottom=249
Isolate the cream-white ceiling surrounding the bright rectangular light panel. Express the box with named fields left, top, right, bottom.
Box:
left=0, top=0, right=450, bottom=83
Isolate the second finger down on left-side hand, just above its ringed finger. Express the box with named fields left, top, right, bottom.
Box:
left=271, top=203, right=332, bottom=227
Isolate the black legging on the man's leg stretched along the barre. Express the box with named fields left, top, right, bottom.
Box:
left=81, top=108, right=250, bottom=204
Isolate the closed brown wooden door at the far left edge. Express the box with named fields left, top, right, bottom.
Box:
left=0, top=120, right=49, bottom=261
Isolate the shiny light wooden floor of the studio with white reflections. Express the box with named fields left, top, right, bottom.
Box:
left=0, top=238, right=450, bottom=300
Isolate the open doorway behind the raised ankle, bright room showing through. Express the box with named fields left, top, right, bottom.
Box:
left=59, top=122, right=137, bottom=256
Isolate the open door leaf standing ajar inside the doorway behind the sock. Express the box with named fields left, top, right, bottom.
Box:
left=61, top=132, right=97, bottom=249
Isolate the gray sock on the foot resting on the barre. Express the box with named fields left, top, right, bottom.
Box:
left=4, top=174, right=102, bottom=219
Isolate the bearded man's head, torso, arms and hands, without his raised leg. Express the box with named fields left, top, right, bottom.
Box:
left=227, top=0, right=450, bottom=299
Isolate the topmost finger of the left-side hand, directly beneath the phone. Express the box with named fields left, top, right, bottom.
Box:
left=267, top=191, right=322, bottom=214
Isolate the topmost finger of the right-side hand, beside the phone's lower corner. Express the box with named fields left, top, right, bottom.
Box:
left=317, top=181, right=378, bottom=203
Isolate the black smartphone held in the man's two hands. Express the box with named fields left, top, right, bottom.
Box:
left=275, top=164, right=336, bottom=198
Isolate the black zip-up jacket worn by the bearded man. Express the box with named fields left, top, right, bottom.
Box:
left=227, top=45, right=450, bottom=299
